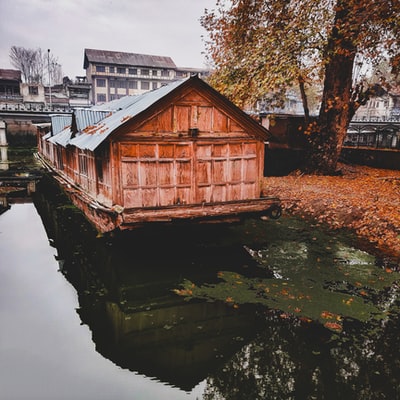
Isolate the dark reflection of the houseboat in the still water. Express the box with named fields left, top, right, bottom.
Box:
left=35, top=179, right=266, bottom=391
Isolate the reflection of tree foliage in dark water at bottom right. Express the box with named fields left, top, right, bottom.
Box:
left=204, top=317, right=400, bottom=400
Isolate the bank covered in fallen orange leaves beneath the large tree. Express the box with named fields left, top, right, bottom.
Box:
left=264, top=164, right=400, bottom=260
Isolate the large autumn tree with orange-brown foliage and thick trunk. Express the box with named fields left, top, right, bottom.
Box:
left=201, top=0, right=400, bottom=173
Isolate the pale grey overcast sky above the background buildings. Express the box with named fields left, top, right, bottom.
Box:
left=0, top=0, right=216, bottom=78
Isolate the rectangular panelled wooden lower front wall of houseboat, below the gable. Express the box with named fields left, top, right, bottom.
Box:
left=120, top=141, right=260, bottom=208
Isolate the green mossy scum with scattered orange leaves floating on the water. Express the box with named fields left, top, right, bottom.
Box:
left=176, top=218, right=399, bottom=331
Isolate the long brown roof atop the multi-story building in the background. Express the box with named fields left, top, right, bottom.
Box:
left=83, top=49, right=176, bottom=68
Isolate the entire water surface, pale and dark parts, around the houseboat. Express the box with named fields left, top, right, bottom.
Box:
left=0, top=176, right=400, bottom=400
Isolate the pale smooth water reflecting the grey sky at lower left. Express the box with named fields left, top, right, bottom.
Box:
left=0, top=203, right=209, bottom=400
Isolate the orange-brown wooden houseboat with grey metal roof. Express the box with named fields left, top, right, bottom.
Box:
left=38, top=76, right=280, bottom=232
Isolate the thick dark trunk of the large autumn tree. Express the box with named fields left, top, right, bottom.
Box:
left=307, top=0, right=357, bottom=174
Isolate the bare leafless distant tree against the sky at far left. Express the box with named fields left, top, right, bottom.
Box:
left=10, top=46, right=62, bottom=84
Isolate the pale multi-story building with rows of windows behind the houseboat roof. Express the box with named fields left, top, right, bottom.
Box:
left=83, top=49, right=206, bottom=104
